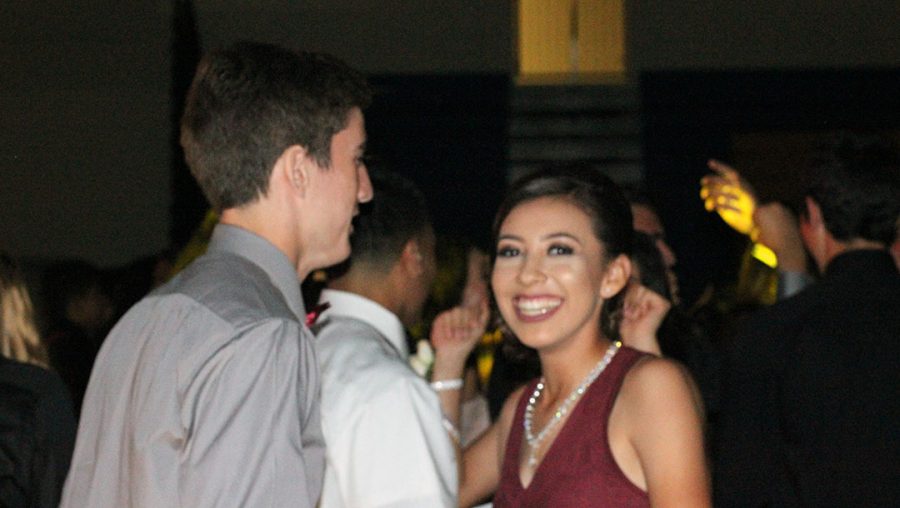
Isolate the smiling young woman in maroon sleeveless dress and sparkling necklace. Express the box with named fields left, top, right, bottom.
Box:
left=460, top=176, right=710, bottom=508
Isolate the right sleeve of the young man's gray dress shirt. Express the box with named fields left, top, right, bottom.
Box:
left=179, top=319, right=320, bottom=507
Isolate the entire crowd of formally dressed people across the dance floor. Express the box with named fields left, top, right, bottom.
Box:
left=0, top=42, right=900, bottom=508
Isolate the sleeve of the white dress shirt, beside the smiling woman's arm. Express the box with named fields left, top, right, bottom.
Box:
left=323, top=375, right=458, bottom=508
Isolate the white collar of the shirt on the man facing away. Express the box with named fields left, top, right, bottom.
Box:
left=319, top=289, right=409, bottom=358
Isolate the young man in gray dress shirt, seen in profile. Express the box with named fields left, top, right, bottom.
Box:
left=62, top=43, right=372, bottom=508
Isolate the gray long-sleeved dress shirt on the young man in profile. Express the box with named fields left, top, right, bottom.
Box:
left=62, top=225, right=324, bottom=508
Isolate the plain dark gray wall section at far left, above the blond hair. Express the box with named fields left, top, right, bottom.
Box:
left=0, top=0, right=169, bottom=264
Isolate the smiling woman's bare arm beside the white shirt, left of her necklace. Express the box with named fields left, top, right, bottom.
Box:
left=459, top=388, right=524, bottom=507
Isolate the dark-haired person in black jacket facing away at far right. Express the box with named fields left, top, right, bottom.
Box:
left=713, top=135, right=900, bottom=507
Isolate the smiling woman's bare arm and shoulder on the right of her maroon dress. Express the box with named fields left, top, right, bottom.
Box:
left=610, top=358, right=712, bottom=507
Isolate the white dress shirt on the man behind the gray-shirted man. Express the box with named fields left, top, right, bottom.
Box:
left=314, top=290, right=458, bottom=508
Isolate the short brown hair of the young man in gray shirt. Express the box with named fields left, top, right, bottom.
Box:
left=181, top=42, right=371, bottom=210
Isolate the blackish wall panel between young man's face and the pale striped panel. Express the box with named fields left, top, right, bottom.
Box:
left=366, top=73, right=510, bottom=248
